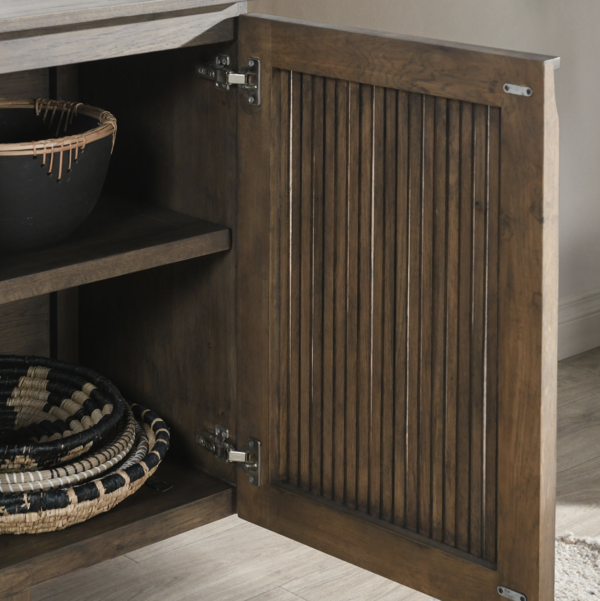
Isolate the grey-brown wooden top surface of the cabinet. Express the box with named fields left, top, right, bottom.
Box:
left=0, top=0, right=241, bottom=33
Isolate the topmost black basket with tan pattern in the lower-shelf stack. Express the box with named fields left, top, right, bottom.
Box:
left=0, top=356, right=125, bottom=472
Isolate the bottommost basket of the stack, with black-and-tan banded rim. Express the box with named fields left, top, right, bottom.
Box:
left=0, top=405, right=170, bottom=534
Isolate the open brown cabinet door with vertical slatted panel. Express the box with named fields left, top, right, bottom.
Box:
left=235, top=16, right=558, bottom=601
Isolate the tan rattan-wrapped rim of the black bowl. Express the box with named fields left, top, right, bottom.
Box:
left=0, top=98, right=117, bottom=157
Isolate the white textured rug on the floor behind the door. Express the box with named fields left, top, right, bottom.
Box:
left=554, top=534, right=600, bottom=601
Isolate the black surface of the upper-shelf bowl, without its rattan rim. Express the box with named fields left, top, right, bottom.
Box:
left=0, top=106, right=113, bottom=253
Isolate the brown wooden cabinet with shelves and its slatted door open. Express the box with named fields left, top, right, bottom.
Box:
left=0, top=7, right=558, bottom=601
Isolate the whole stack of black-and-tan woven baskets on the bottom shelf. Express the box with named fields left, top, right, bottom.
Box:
left=0, top=356, right=169, bottom=534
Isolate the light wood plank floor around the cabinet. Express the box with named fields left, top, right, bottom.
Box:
left=33, top=348, right=600, bottom=601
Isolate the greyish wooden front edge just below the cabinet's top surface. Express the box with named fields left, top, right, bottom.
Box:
left=0, top=4, right=239, bottom=73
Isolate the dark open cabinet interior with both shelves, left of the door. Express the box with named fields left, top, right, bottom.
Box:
left=0, top=44, right=237, bottom=597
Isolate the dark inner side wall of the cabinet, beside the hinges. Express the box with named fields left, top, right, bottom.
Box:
left=79, top=44, right=237, bottom=482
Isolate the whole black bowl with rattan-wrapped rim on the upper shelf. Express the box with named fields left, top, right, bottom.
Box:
left=0, top=99, right=117, bottom=253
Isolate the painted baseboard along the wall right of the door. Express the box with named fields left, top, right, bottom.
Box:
left=558, top=289, right=600, bottom=359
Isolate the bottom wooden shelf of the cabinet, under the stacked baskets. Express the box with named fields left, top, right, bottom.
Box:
left=0, top=461, right=235, bottom=598
